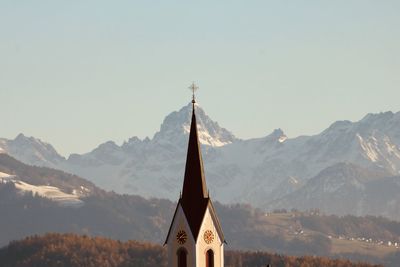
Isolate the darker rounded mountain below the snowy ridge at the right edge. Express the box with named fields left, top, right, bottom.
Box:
left=267, top=163, right=400, bottom=220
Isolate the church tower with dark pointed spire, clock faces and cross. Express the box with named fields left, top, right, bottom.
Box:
left=165, top=83, right=225, bottom=267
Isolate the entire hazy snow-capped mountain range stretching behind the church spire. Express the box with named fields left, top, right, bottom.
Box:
left=0, top=105, right=400, bottom=218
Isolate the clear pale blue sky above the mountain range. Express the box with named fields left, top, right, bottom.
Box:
left=0, top=0, right=400, bottom=156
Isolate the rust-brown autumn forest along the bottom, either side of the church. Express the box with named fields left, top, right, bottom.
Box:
left=0, top=234, right=377, bottom=267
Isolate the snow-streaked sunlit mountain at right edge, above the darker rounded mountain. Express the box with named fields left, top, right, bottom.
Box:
left=307, top=112, right=400, bottom=175
